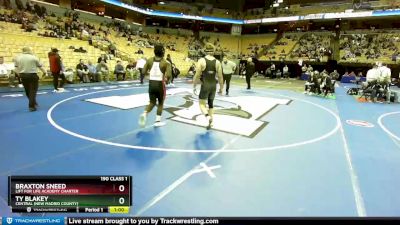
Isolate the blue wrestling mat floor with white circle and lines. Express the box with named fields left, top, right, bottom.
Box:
left=0, top=78, right=400, bottom=217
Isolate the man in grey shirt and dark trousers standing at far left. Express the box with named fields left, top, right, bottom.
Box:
left=14, top=47, right=46, bottom=112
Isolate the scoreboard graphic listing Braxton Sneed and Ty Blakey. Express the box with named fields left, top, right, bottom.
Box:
left=8, top=176, right=132, bottom=213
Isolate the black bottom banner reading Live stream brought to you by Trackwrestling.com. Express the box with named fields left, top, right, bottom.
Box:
left=0, top=217, right=400, bottom=225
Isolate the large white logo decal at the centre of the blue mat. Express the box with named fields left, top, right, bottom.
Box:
left=86, top=88, right=291, bottom=138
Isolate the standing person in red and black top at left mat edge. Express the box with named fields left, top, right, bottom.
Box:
left=48, top=48, right=66, bottom=92
